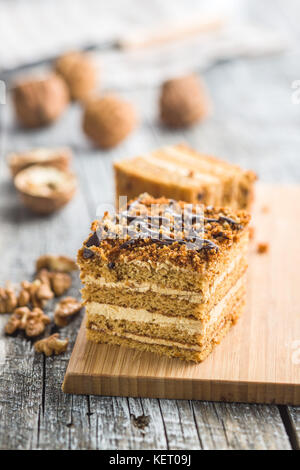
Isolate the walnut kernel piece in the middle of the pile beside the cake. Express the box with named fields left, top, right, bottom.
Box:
left=18, top=279, right=54, bottom=308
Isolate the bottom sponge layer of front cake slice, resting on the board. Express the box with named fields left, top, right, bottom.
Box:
left=86, top=301, right=244, bottom=362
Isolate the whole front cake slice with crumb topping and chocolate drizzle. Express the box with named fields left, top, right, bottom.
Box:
left=78, top=194, right=249, bottom=362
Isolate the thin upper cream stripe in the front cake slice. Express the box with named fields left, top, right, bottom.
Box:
left=83, top=255, right=244, bottom=304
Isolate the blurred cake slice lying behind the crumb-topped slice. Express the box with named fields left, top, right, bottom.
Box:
left=114, top=144, right=256, bottom=209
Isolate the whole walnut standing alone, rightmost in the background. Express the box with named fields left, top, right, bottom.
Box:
left=159, top=75, right=211, bottom=128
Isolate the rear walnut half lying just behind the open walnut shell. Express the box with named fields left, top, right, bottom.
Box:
left=7, top=148, right=72, bottom=178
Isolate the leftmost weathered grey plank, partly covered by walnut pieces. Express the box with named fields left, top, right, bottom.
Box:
left=0, top=107, right=43, bottom=449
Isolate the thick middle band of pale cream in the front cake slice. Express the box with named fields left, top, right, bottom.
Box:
left=86, top=275, right=245, bottom=338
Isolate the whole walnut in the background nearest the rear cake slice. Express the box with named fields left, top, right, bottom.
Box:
left=82, top=94, right=137, bottom=149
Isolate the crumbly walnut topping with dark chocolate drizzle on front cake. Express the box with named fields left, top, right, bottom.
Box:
left=79, top=194, right=250, bottom=270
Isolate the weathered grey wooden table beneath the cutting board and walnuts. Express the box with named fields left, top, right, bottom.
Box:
left=0, top=1, right=300, bottom=449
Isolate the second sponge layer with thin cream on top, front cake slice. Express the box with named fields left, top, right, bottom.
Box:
left=81, top=257, right=247, bottom=319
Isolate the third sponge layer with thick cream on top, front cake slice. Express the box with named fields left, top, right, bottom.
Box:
left=86, top=277, right=245, bottom=345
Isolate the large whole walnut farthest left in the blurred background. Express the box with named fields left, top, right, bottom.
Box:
left=13, top=74, right=69, bottom=128
